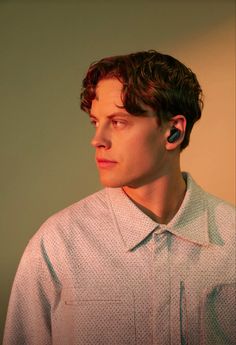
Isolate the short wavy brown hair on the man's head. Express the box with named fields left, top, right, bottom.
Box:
left=81, top=50, right=203, bottom=150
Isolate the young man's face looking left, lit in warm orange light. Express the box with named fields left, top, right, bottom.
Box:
left=90, top=78, right=169, bottom=188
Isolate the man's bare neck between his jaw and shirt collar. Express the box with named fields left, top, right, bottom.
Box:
left=123, top=169, right=186, bottom=224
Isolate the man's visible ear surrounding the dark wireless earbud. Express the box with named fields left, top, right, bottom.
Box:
left=165, top=115, right=187, bottom=150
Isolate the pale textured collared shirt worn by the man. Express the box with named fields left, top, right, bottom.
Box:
left=3, top=174, right=236, bottom=345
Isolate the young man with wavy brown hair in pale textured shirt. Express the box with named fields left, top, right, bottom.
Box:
left=4, top=51, right=236, bottom=345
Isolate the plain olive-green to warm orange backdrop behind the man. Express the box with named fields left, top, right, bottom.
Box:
left=0, top=0, right=235, bottom=338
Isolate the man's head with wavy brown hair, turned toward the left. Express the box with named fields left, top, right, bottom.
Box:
left=81, top=51, right=201, bottom=189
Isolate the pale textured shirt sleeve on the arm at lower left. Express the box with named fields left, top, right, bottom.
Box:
left=3, top=238, right=52, bottom=345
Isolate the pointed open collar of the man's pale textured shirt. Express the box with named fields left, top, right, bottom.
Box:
left=106, top=173, right=209, bottom=250
